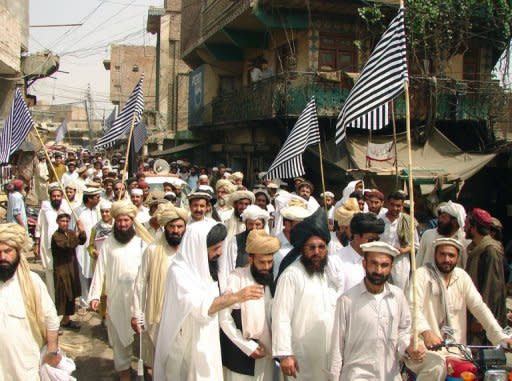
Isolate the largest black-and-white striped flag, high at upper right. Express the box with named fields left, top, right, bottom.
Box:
left=336, top=8, right=408, bottom=144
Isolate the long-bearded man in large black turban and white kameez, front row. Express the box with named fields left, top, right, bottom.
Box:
left=272, top=208, right=337, bottom=380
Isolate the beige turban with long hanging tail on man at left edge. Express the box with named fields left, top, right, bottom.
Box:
left=0, top=223, right=46, bottom=348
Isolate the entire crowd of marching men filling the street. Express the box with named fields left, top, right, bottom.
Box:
left=0, top=149, right=512, bottom=381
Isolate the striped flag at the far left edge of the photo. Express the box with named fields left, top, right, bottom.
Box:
left=0, top=88, right=34, bottom=164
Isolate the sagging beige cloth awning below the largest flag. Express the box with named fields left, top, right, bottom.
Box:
left=326, top=129, right=496, bottom=194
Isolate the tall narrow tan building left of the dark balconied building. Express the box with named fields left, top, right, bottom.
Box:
left=147, top=0, right=193, bottom=154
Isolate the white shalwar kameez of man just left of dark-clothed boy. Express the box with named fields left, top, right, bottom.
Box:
left=35, top=200, right=71, bottom=300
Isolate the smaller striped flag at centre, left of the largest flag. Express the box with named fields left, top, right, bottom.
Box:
left=265, top=98, right=320, bottom=179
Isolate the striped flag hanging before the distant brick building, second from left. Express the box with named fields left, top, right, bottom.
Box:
left=94, top=75, right=144, bottom=149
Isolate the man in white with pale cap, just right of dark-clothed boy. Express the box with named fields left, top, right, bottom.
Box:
left=75, top=187, right=103, bottom=306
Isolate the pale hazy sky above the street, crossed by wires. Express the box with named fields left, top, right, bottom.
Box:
left=29, top=0, right=163, bottom=118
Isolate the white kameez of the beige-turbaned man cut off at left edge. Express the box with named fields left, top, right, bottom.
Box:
left=0, top=272, right=59, bottom=381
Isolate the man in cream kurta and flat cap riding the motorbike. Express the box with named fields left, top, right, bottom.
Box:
left=406, top=238, right=512, bottom=381
